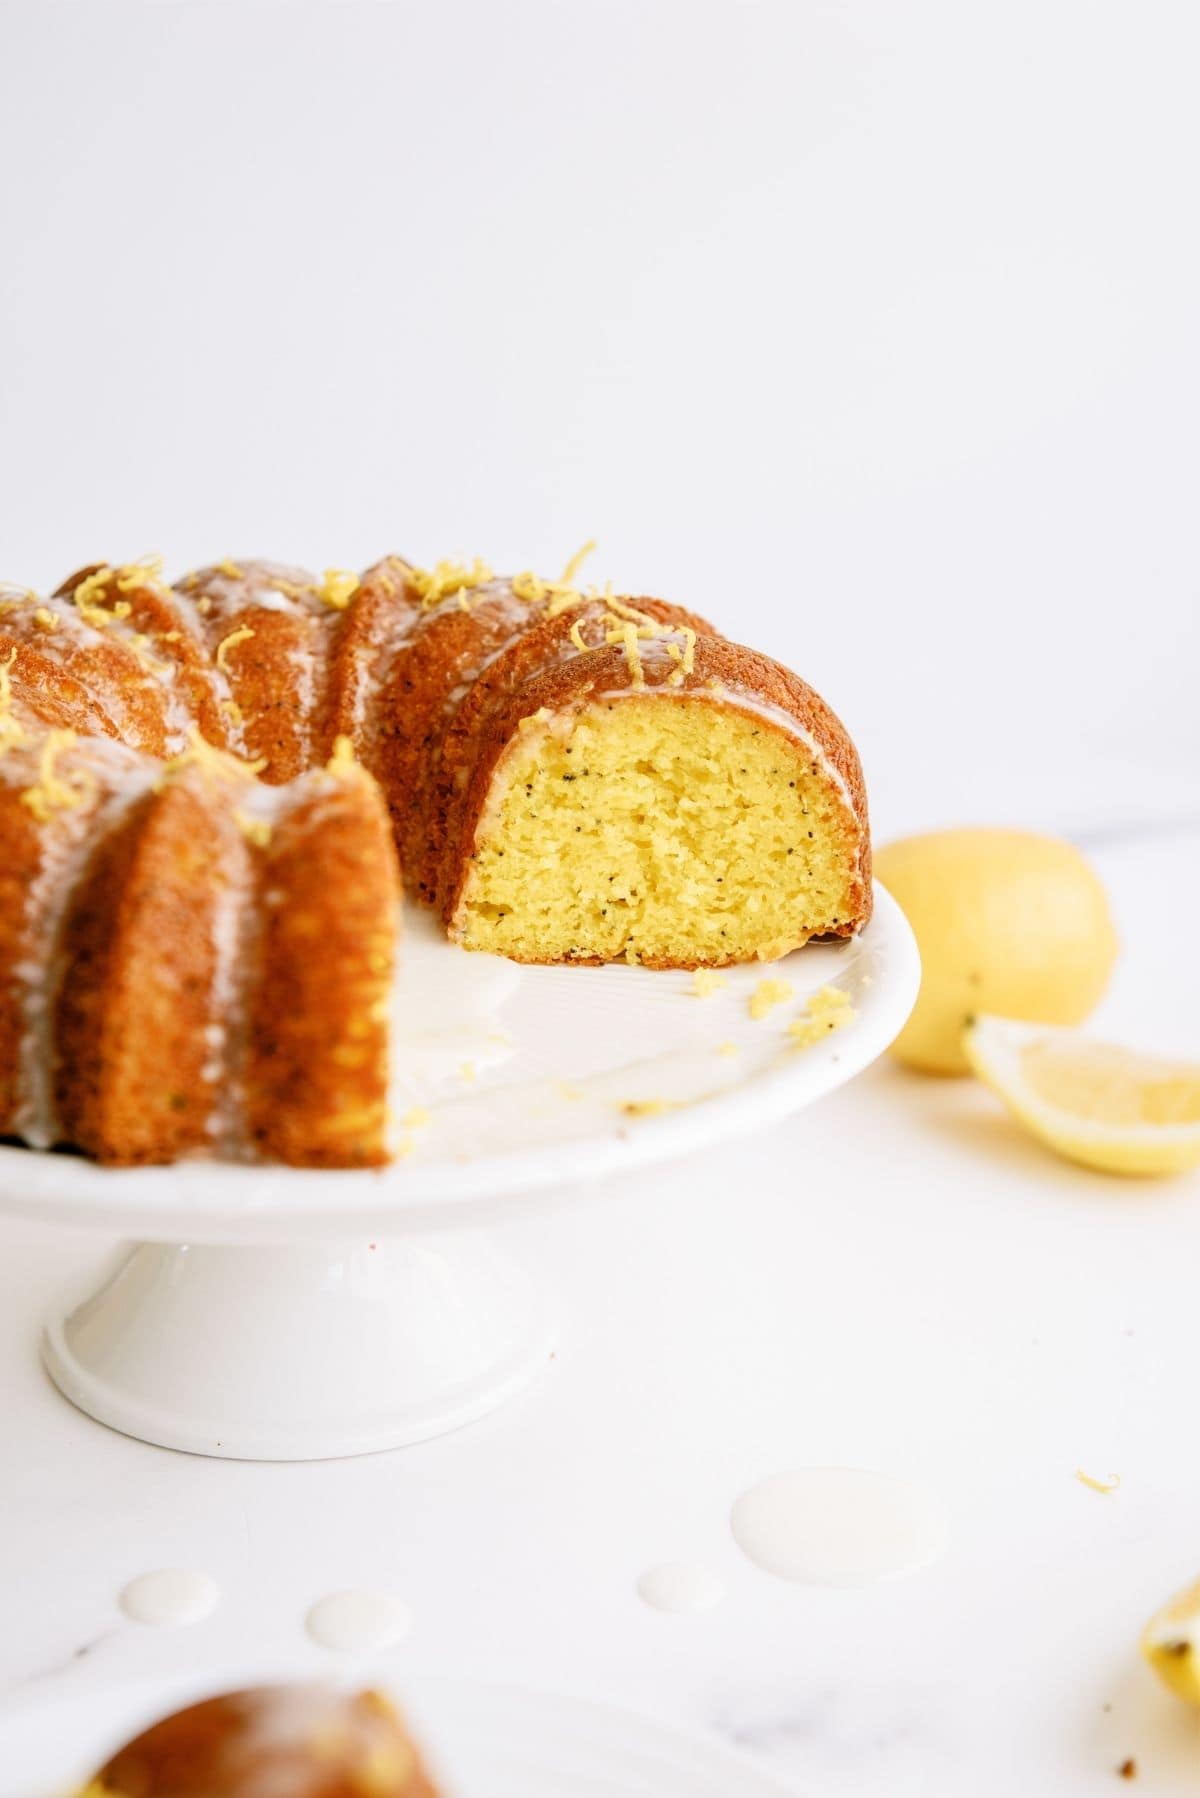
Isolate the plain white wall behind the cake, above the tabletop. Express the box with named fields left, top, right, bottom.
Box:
left=0, top=0, right=1200, bottom=832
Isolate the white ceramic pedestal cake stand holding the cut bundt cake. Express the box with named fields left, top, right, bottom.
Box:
left=0, top=888, right=919, bottom=1460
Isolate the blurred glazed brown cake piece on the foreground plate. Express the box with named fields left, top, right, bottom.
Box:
left=79, top=1687, right=437, bottom=1798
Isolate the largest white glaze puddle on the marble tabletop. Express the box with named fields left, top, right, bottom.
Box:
left=729, top=1467, right=946, bottom=1586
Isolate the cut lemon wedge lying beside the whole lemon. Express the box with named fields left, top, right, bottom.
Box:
left=963, top=1016, right=1200, bottom=1174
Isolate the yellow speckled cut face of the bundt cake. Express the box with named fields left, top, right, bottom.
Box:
left=459, top=694, right=853, bottom=966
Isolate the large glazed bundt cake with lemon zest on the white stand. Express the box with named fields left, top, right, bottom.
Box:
left=0, top=556, right=871, bottom=1167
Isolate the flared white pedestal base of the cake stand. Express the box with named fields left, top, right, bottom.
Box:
left=43, top=1230, right=552, bottom=1460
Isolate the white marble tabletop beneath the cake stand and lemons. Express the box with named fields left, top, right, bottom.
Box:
left=0, top=834, right=1200, bottom=1798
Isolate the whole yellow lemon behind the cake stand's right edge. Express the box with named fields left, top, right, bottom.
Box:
left=874, top=831, right=1117, bottom=1073
